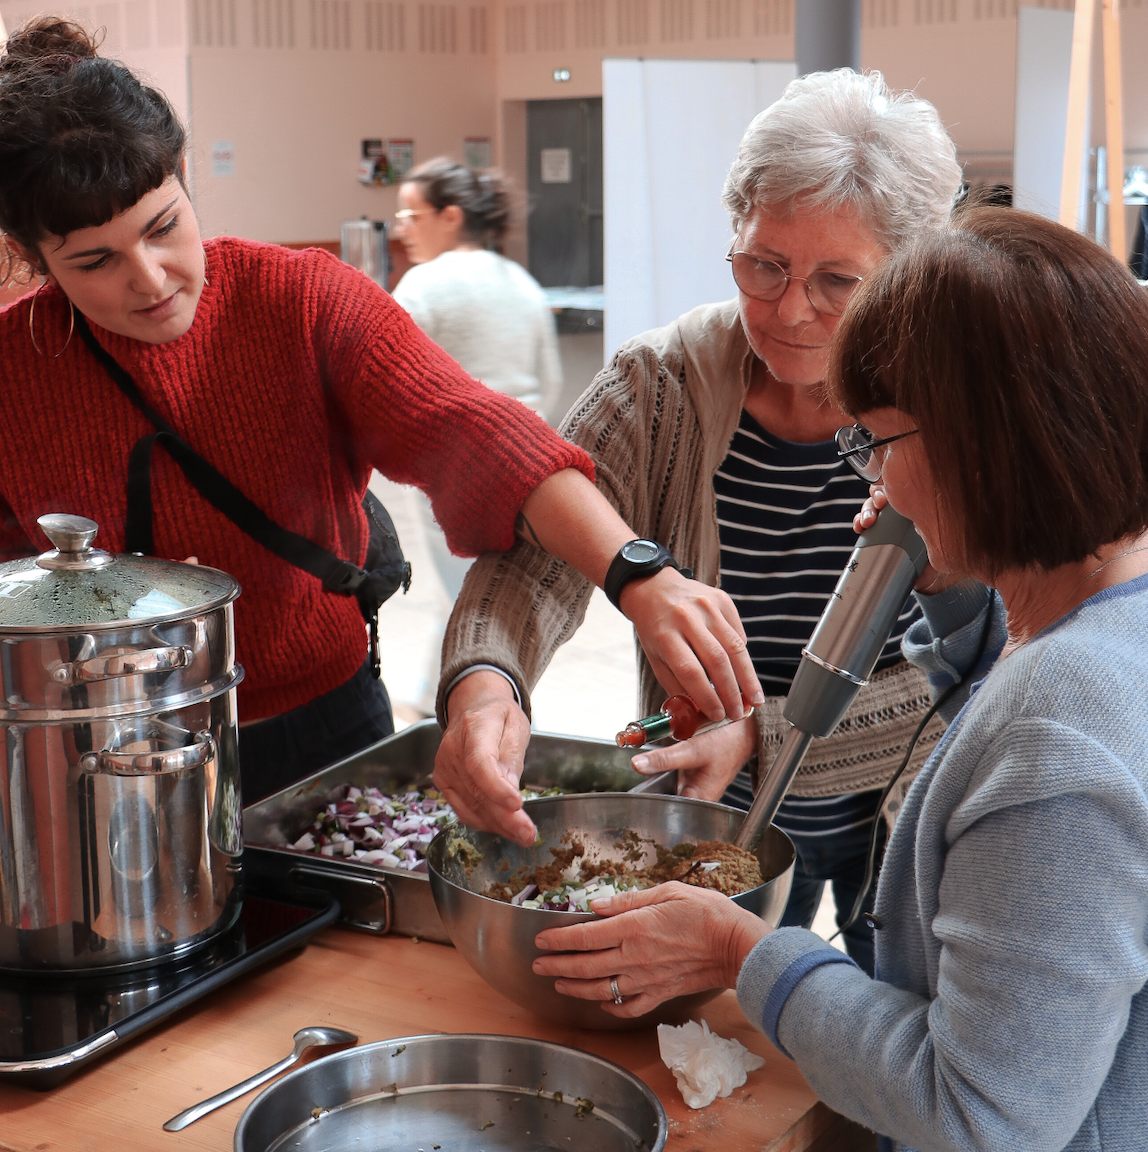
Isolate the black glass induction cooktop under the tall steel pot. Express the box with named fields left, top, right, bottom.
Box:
left=0, top=890, right=339, bottom=1090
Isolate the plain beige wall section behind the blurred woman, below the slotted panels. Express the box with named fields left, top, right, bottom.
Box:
left=184, top=42, right=495, bottom=241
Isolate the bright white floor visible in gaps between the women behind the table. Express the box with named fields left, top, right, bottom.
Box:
left=371, top=475, right=842, bottom=948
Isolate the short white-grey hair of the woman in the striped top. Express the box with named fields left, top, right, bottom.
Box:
left=722, top=68, right=961, bottom=249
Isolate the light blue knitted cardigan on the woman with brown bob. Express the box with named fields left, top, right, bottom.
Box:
left=737, top=577, right=1148, bottom=1152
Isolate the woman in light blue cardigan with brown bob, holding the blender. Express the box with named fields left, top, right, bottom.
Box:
left=535, top=209, right=1148, bottom=1152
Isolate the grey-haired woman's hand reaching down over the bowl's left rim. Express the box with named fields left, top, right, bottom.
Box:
left=434, top=672, right=538, bottom=847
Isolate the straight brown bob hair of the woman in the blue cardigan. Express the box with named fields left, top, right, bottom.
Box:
left=827, top=207, right=1148, bottom=576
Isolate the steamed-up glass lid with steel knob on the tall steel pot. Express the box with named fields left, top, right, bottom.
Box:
left=0, top=513, right=240, bottom=631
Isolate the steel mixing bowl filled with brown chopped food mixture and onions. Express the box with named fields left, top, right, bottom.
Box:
left=427, top=793, right=795, bottom=1029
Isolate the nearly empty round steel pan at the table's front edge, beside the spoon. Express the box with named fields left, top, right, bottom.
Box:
left=234, top=1034, right=668, bottom=1152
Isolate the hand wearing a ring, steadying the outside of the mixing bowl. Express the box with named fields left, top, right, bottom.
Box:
left=534, top=881, right=770, bottom=1017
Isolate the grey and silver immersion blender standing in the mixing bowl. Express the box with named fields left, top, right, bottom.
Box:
left=733, top=505, right=929, bottom=850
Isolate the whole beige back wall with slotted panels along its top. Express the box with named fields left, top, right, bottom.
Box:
left=0, top=0, right=1148, bottom=241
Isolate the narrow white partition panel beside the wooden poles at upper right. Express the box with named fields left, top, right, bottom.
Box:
left=1012, top=6, right=1088, bottom=220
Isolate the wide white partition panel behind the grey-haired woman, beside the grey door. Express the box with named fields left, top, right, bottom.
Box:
left=602, top=60, right=797, bottom=361
